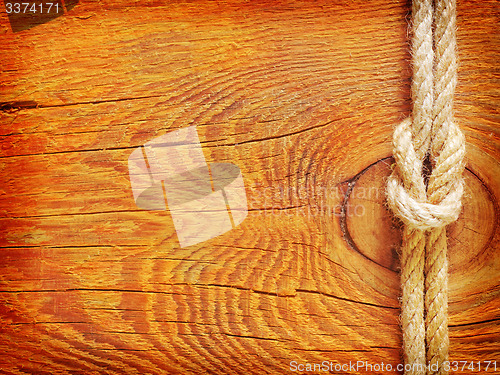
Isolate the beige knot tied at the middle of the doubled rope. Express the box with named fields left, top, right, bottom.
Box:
left=387, top=118, right=465, bottom=230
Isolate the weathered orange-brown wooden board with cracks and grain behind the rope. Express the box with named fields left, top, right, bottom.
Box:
left=0, top=0, right=500, bottom=374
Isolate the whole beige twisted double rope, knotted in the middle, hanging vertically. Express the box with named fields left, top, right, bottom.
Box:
left=387, top=0, right=465, bottom=375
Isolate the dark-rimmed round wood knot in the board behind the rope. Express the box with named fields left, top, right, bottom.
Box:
left=342, top=158, right=497, bottom=271
